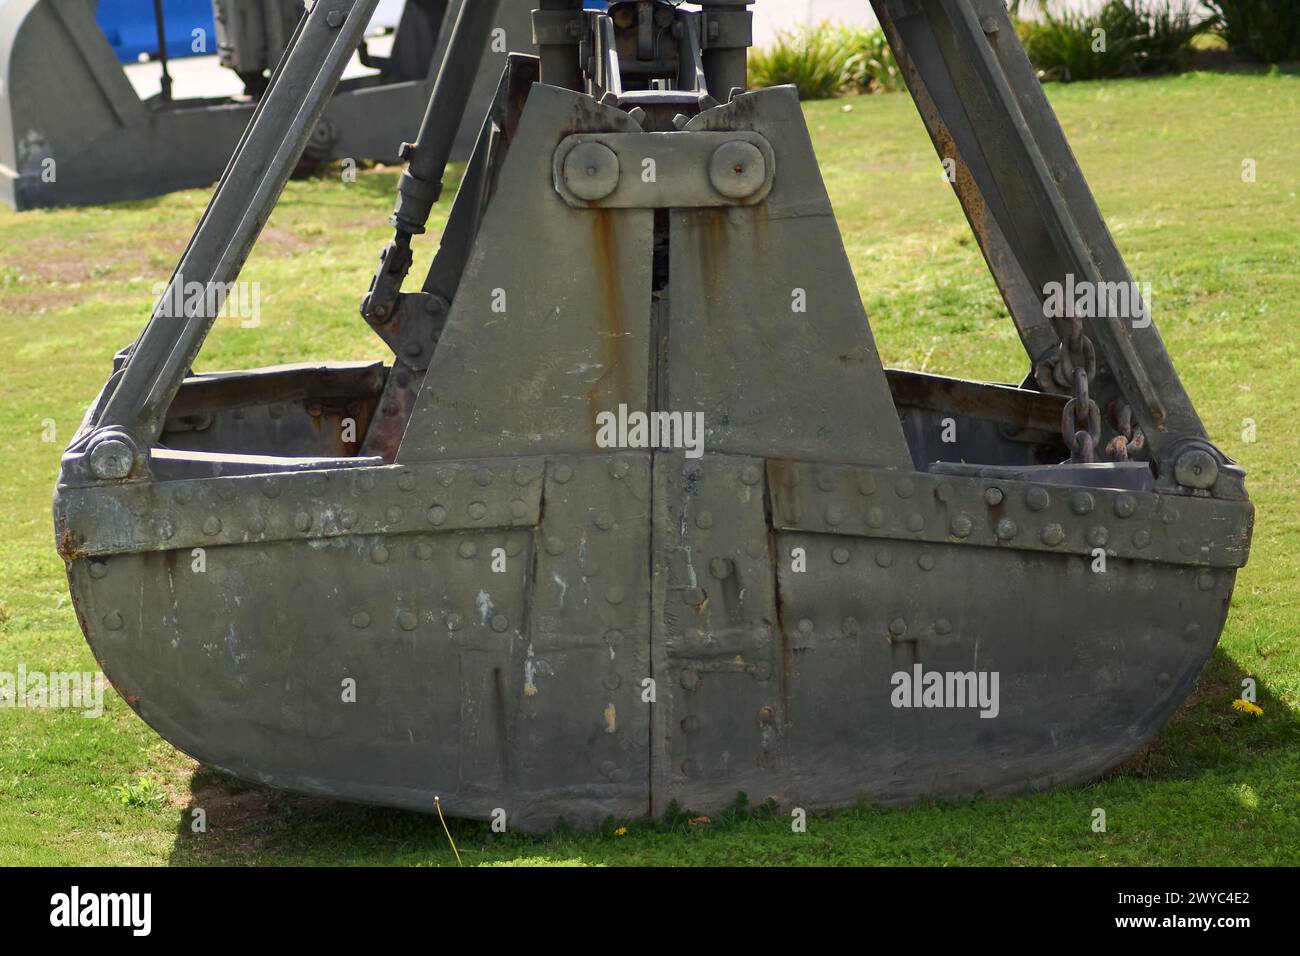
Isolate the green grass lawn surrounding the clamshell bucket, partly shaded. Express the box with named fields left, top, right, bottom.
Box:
left=0, top=74, right=1300, bottom=865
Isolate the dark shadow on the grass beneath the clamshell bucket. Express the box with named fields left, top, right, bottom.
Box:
left=162, top=652, right=1300, bottom=866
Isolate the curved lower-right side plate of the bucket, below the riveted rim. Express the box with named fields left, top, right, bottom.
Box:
left=776, top=533, right=1235, bottom=808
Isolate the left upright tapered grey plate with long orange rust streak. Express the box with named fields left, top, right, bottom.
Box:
left=398, top=86, right=654, bottom=462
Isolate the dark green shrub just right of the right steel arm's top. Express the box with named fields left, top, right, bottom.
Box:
left=1017, top=0, right=1208, bottom=81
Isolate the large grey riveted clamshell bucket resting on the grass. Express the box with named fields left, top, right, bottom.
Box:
left=55, top=3, right=1253, bottom=829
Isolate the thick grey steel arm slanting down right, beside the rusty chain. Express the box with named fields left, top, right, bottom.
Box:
left=871, top=0, right=1239, bottom=490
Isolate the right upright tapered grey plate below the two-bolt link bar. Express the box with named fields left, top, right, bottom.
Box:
left=663, top=87, right=911, bottom=467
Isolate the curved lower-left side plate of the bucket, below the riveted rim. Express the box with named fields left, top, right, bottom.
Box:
left=70, top=529, right=532, bottom=817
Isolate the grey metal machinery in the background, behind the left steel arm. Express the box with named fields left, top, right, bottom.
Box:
left=0, top=0, right=532, bottom=209
